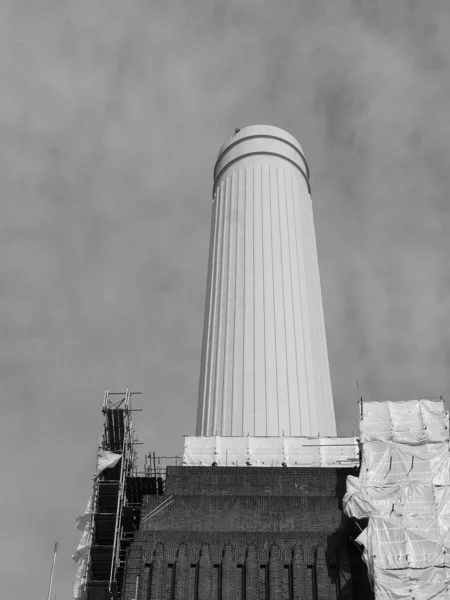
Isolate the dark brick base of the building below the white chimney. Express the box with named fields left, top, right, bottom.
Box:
left=123, top=467, right=372, bottom=600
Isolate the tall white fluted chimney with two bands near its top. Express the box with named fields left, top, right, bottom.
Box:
left=197, top=125, right=336, bottom=436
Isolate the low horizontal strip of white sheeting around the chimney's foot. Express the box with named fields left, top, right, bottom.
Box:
left=183, top=436, right=359, bottom=467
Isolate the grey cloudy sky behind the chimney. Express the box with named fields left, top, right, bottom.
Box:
left=0, top=0, right=450, bottom=600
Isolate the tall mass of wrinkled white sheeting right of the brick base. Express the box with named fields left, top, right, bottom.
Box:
left=344, top=400, right=450, bottom=600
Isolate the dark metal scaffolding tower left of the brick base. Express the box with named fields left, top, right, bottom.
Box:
left=86, top=388, right=158, bottom=600
